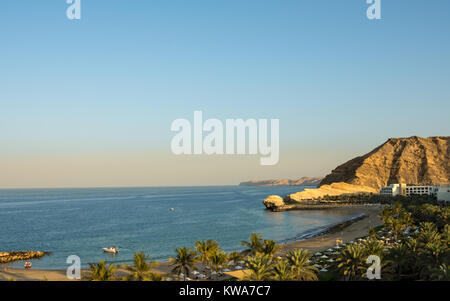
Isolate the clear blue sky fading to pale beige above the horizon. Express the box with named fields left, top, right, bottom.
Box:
left=0, top=0, right=450, bottom=188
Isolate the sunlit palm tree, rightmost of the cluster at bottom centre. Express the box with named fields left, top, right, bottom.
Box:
left=286, top=249, right=319, bottom=281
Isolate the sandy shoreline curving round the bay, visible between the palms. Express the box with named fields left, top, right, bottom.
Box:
left=0, top=204, right=384, bottom=281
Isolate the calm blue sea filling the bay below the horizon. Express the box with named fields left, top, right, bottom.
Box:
left=0, top=186, right=356, bottom=269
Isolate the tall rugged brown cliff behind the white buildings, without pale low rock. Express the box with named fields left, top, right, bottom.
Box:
left=320, top=136, right=450, bottom=189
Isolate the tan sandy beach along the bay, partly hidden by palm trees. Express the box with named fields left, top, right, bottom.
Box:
left=0, top=205, right=382, bottom=281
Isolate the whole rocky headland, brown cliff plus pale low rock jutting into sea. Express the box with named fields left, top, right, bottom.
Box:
left=263, top=136, right=450, bottom=211
